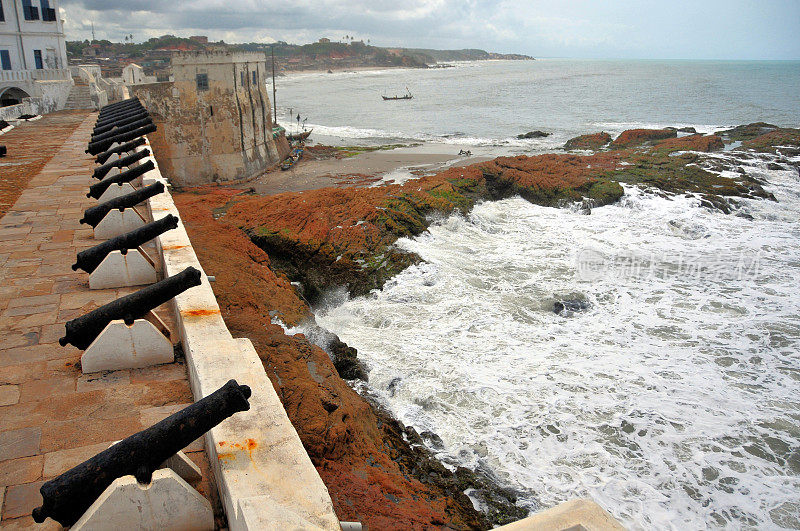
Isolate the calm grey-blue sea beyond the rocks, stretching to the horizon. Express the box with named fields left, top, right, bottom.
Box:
left=277, top=59, right=800, bottom=154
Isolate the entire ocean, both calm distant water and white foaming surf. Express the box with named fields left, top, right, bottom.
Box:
left=278, top=60, right=800, bottom=530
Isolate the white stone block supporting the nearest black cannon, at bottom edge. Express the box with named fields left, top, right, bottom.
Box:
left=72, top=469, right=214, bottom=531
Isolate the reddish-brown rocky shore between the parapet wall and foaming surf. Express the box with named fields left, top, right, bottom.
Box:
left=174, top=124, right=800, bottom=529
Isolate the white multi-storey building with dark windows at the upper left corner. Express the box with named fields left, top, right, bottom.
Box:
left=0, top=0, right=73, bottom=112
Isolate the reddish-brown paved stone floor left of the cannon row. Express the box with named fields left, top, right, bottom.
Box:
left=0, top=113, right=221, bottom=528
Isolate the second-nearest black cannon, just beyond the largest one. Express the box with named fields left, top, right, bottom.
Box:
left=58, top=266, right=201, bottom=350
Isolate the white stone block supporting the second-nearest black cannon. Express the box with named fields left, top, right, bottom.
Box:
left=81, top=319, right=175, bottom=373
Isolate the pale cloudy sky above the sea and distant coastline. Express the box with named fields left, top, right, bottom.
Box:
left=60, top=0, right=800, bottom=59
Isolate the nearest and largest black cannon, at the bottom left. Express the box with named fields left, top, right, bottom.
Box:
left=33, top=380, right=252, bottom=526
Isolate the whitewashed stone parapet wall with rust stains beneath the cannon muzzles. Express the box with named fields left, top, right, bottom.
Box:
left=139, top=139, right=340, bottom=530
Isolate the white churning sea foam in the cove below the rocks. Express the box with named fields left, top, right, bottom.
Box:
left=318, top=163, right=800, bottom=529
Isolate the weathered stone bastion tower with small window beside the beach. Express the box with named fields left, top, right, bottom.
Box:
left=129, top=52, right=289, bottom=185
